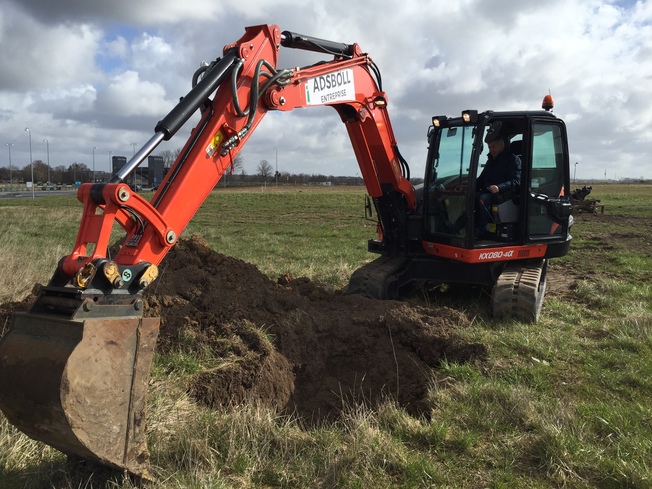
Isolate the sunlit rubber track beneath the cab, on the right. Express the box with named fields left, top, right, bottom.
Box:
left=491, top=260, right=546, bottom=323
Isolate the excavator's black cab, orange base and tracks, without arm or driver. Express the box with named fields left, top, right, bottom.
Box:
left=398, top=106, right=572, bottom=322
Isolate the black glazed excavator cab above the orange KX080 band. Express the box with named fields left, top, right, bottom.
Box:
left=423, top=111, right=570, bottom=250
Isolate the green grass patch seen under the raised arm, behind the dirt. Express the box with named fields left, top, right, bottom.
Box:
left=185, top=188, right=375, bottom=288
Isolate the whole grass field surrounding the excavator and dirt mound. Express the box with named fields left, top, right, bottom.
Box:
left=0, top=184, right=652, bottom=489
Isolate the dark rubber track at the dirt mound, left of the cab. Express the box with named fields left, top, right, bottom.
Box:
left=346, top=256, right=407, bottom=299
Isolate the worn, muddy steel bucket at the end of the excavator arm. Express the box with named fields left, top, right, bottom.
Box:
left=0, top=312, right=160, bottom=480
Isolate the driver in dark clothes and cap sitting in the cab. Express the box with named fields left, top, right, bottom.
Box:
left=475, top=129, right=521, bottom=238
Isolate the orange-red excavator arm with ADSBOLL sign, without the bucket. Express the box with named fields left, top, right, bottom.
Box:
left=57, top=26, right=415, bottom=290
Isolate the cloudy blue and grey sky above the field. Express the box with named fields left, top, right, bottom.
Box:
left=0, top=0, right=652, bottom=183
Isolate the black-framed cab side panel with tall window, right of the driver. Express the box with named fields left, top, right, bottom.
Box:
left=523, top=118, right=571, bottom=243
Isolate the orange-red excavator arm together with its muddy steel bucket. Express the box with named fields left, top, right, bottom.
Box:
left=0, top=25, right=416, bottom=478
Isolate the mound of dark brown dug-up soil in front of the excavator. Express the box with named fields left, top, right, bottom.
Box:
left=147, top=237, right=486, bottom=419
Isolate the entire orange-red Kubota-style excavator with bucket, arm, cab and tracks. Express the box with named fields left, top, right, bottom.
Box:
left=0, top=25, right=572, bottom=479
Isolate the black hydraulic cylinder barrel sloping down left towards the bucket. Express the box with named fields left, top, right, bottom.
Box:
left=154, top=49, right=238, bottom=141
